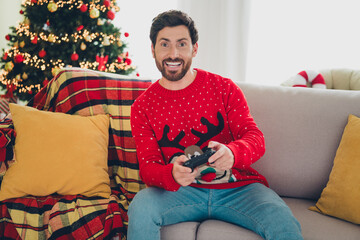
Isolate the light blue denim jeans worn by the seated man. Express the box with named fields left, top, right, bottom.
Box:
left=127, top=183, right=303, bottom=240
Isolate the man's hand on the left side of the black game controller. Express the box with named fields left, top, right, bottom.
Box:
left=172, top=155, right=198, bottom=187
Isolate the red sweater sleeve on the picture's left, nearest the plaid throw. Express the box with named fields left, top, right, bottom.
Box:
left=131, top=101, right=180, bottom=191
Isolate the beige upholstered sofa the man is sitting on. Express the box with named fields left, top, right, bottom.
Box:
left=162, top=83, right=360, bottom=240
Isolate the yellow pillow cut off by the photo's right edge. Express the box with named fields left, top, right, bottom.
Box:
left=310, top=115, right=360, bottom=224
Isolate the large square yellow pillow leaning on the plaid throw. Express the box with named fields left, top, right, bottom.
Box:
left=0, top=104, right=111, bottom=201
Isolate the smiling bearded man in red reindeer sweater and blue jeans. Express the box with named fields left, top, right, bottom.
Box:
left=128, top=10, right=302, bottom=240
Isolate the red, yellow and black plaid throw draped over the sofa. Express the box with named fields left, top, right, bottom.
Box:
left=0, top=68, right=151, bottom=239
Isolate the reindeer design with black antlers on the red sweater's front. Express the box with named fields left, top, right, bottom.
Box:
left=158, top=112, right=235, bottom=184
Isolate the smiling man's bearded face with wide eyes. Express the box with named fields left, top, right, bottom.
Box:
left=151, top=25, right=198, bottom=81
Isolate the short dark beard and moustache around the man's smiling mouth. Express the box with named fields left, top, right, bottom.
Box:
left=155, top=58, right=192, bottom=82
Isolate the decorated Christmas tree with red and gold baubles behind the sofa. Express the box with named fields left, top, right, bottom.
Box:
left=0, top=0, right=135, bottom=101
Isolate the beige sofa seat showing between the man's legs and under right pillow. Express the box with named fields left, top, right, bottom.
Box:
left=161, top=198, right=360, bottom=240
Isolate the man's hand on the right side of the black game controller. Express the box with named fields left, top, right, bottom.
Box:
left=208, top=141, right=235, bottom=171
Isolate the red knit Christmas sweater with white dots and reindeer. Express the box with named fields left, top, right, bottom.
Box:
left=131, top=69, right=268, bottom=191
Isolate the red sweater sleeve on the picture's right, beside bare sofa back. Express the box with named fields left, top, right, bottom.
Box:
left=224, top=80, right=265, bottom=168
